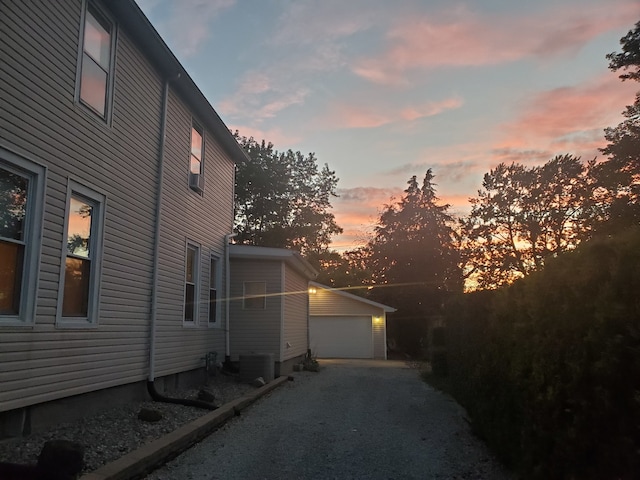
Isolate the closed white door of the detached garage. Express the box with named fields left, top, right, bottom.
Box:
left=309, top=316, right=373, bottom=358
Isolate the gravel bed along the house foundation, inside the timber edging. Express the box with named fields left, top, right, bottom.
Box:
left=0, top=375, right=255, bottom=473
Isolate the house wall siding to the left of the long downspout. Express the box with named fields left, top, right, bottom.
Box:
left=0, top=0, right=160, bottom=411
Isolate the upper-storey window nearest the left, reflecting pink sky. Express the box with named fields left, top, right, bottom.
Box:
left=78, top=2, right=115, bottom=120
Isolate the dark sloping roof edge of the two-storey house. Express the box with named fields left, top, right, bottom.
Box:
left=105, top=0, right=248, bottom=163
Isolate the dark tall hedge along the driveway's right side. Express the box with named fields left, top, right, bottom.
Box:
left=446, top=230, right=640, bottom=479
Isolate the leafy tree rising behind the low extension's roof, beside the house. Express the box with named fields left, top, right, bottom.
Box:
left=234, top=132, right=342, bottom=255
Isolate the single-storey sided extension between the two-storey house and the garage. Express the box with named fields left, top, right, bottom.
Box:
left=229, top=245, right=318, bottom=375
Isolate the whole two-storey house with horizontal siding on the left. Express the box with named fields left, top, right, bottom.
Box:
left=0, top=0, right=245, bottom=436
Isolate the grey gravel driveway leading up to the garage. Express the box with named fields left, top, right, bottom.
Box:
left=147, top=360, right=508, bottom=480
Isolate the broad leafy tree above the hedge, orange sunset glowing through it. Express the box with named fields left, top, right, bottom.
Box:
left=461, top=155, right=594, bottom=288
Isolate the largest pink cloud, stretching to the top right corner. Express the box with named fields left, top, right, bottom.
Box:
left=352, top=0, right=640, bottom=85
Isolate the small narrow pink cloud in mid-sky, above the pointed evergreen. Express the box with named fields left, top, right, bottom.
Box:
left=324, top=97, right=463, bottom=128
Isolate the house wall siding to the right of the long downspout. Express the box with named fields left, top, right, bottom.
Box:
left=155, top=88, right=234, bottom=376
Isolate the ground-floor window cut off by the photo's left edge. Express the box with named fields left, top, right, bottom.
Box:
left=0, top=148, right=46, bottom=325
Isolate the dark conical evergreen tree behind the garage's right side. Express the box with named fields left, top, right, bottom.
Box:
left=366, top=169, right=462, bottom=353
